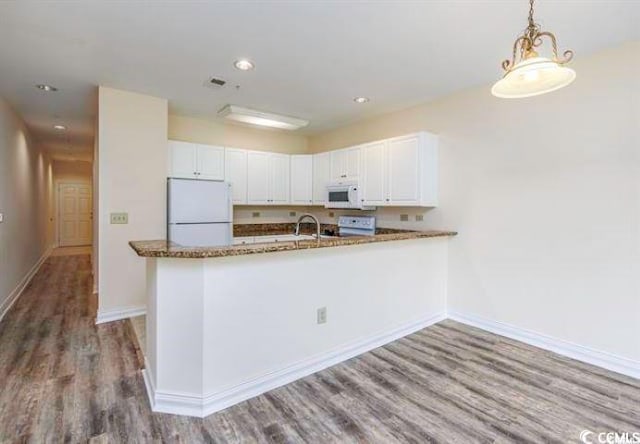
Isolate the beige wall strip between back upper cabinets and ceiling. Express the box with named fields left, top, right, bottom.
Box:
left=169, top=115, right=308, bottom=154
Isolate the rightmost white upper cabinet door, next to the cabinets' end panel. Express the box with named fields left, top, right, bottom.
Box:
left=388, top=136, right=421, bottom=205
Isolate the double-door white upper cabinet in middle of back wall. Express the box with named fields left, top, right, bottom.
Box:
left=247, top=151, right=290, bottom=205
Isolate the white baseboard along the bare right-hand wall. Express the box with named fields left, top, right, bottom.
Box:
left=448, top=310, right=640, bottom=379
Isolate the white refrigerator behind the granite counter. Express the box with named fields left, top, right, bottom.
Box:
left=167, top=178, right=233, bottom=247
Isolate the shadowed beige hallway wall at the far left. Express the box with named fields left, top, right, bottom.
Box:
left=0, top=98, right=53, bottom=318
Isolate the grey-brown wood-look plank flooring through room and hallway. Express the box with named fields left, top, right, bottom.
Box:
left=0, top=256, right=640, bottom=443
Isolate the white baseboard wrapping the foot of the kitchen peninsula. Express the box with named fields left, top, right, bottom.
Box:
left=144, top=312, right=446, bottom=418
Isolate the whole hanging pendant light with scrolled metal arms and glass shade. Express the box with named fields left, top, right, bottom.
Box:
left=491, top=0, right=576, bottom=99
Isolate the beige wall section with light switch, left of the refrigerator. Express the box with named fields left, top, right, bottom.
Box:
left=98, top=87, right=167, bottom=321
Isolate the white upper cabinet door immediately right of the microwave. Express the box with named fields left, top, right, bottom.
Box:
left=360, top=142, right=389, bottom=205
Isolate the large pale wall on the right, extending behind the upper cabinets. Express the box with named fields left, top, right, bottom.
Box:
left=310, top=42, right=640, bottom=361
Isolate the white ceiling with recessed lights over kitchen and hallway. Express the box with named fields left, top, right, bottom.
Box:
left=0, top=0, right=640, bottom=157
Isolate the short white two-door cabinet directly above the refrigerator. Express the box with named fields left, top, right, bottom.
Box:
left=168, top=140, right=224, bottom=180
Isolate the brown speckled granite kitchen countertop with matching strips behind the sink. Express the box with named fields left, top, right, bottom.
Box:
left=129, top=223, right=458, bottom=259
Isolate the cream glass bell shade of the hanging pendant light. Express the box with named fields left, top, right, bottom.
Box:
left=491, top=57, right=576, bottom=99
